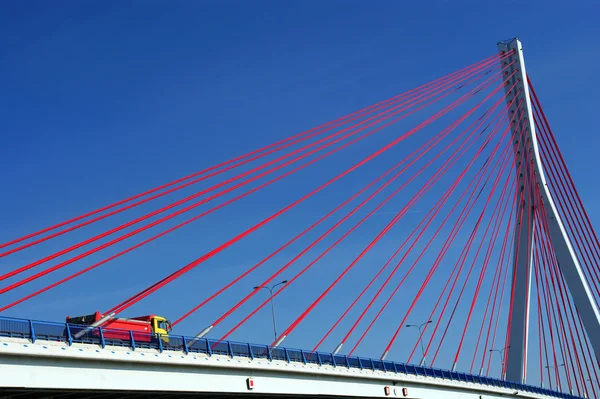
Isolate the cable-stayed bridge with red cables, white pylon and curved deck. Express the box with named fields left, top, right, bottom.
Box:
left=0, top=39, right=600, bottom=399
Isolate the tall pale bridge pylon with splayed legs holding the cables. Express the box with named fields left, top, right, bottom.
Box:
left=498, top=38, right=600, bottom=383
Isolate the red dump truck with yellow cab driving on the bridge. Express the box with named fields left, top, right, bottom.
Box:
left=67, top=312, right=171, bottom=342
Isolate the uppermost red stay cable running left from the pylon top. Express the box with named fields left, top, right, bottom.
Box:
left=0, top=56, right=506, bottom=253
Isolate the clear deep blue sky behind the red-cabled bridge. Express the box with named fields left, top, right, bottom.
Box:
left=0, top=0, right=600, bottom=378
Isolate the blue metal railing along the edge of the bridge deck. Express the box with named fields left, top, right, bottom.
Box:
left=0, top=317, right=577, bottom=399
